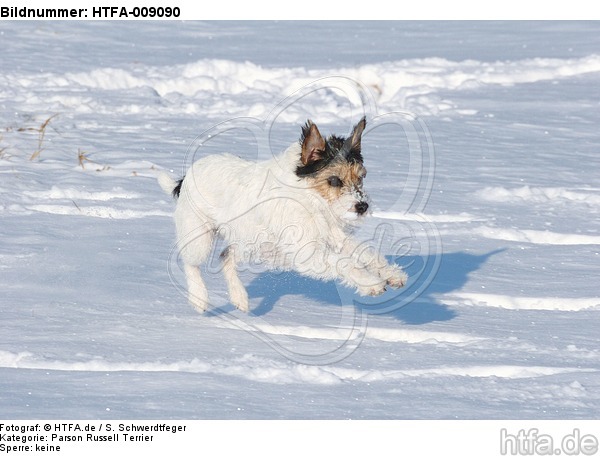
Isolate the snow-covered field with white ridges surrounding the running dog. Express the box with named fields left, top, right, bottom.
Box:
left=0, top=21, right=600, bottom=419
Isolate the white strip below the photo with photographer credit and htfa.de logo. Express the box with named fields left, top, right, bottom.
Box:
left=0, top=420, right=600, bottom=456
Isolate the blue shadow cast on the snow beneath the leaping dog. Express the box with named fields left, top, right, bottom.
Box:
left=247, top=250, right=503, bottom=325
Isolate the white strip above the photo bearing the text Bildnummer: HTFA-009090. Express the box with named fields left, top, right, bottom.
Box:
left=2, top=0, right=600, bottom=20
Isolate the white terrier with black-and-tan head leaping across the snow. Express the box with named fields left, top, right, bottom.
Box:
left=158, top=117, right=407, bottom=312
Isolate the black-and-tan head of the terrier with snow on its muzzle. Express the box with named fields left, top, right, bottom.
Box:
left=296, top=117, right=369, bottom=220
